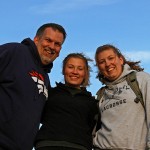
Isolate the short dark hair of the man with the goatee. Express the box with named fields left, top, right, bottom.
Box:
left=36, top=23, right=67, bottom=41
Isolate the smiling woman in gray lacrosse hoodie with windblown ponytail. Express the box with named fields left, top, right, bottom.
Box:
left=94, top=45, right=150, bottom=150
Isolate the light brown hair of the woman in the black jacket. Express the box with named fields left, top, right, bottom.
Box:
left=62, top=53, right=93, bottom=87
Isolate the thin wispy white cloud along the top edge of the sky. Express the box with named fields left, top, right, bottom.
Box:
left=30, top=0, right=119, bottom=14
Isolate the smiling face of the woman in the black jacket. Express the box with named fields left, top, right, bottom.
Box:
left=64, top=57, right=86, bottom=88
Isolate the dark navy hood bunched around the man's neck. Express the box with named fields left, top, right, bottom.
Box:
left=21, top=38, right=53, bottom=73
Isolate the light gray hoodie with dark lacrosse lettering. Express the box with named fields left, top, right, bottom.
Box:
left=93, top=64, right=150, bottom=150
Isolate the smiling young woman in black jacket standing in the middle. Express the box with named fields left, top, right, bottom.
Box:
left=35, top=53, right=98, bottom=150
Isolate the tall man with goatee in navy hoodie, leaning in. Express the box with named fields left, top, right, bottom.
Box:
left=0, top=23, right=66, bottom=150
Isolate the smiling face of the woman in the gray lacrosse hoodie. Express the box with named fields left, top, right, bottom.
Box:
left=97, top=48, right=123, bottom=81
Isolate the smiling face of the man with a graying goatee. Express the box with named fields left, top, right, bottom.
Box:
left=34, top=27, right=64, bottom=65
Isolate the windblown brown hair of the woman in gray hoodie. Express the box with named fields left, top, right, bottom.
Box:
left=95, top=44, right=144, bottom=79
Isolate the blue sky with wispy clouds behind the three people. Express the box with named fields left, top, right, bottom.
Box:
left=0, top=0, right=150, bottom=95
